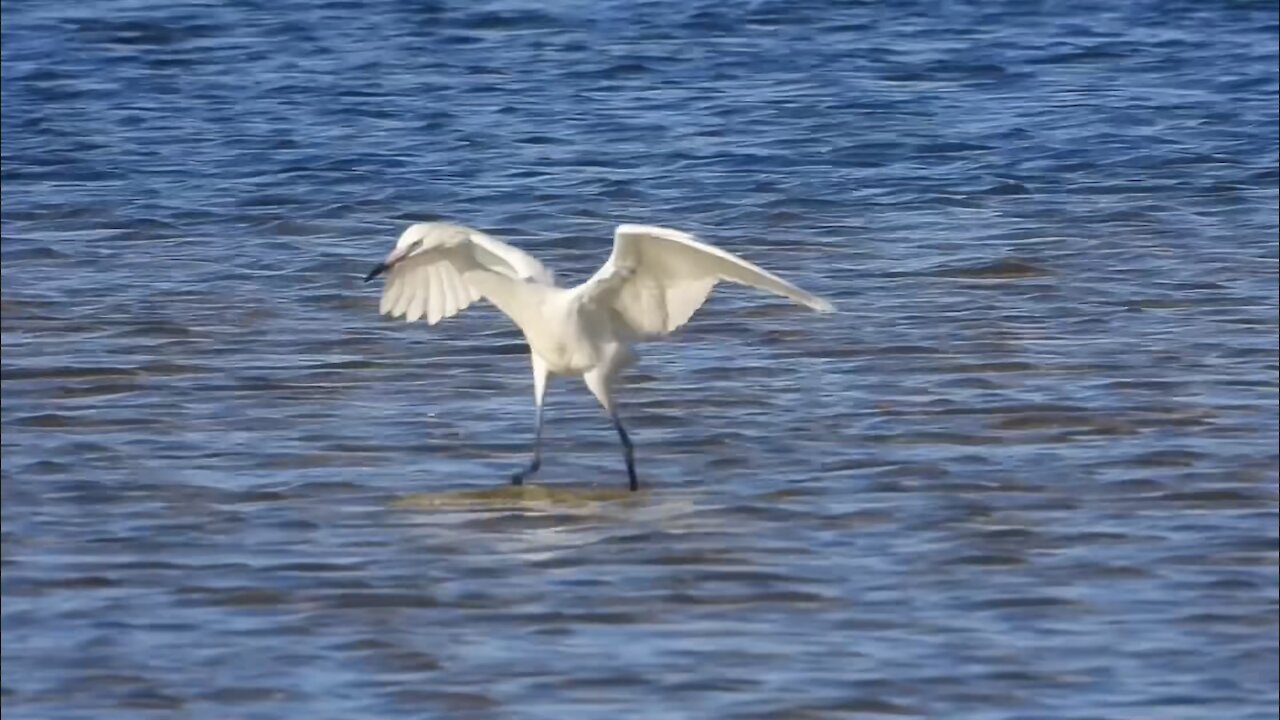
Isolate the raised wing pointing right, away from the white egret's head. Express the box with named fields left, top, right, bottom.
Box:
left=589, top=224, right=835, bottom=337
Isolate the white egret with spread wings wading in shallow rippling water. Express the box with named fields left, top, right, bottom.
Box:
left=365, top=223, right=833, bottom=491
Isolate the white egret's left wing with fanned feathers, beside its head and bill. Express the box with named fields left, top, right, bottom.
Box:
left=378, top=223, right=556, bottom=325
